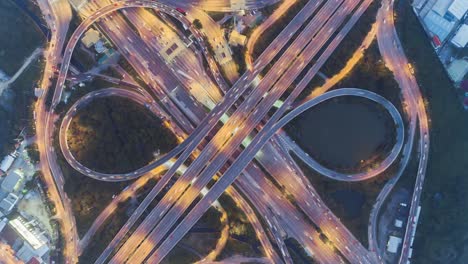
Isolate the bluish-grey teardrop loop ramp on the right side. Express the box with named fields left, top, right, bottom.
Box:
left=272, top=88, right=405, bottom=181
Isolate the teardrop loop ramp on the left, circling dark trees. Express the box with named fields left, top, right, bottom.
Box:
left=59, top=88, right=189, bottom=182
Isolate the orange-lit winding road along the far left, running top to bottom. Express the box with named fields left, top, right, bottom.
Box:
left=35, top=0, right=79, bottom=263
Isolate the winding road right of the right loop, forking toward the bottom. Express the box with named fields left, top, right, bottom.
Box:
left=369, top=0, right=430, bottom=264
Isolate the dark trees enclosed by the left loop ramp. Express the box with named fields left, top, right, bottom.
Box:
left=68, top=97, right=177, bottom=173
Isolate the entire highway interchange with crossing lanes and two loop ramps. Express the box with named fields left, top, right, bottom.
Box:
left=31, top=0, right=429, bottom=264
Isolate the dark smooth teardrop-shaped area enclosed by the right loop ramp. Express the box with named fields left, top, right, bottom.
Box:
left=286, top=96, right=396, bottom=173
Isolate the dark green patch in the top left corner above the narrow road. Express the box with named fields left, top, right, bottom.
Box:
left=0, top=1, right=45, bottom=76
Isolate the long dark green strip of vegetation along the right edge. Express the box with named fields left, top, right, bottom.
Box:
left=395, top=1, right=468, bottom=263
